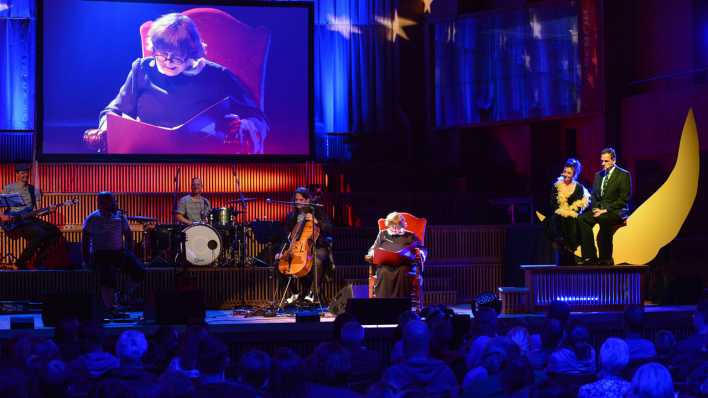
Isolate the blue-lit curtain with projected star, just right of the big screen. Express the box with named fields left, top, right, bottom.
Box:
left=290, top=0, right=398, bottom=160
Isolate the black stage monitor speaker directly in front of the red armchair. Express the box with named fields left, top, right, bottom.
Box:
left=347, top=297, right=411, bottom=325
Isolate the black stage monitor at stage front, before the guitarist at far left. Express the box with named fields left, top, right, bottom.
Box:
left=42, top=293, right=101, bottom=326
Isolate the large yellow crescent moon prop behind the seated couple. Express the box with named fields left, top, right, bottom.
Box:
left=536, top=109, right=700, bottom=265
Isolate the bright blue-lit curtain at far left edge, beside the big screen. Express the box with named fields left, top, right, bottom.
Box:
left=0, top=0, right=36, bottom=130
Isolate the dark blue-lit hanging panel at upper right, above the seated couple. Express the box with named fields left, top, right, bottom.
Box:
left=434, top=6, right=581, bottom=128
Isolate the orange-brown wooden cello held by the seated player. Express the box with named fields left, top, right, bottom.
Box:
left=278, top=204, right=320, bottom=278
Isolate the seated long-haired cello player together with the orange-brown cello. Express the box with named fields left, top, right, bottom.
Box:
left=275, top=187, right=334, bottom=304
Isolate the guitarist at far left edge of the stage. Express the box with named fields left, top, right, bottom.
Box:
left=0, top=164, right=61, bottom=268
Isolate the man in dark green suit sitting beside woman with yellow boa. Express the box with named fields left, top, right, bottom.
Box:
left=579, top=148, right=632, bottom=265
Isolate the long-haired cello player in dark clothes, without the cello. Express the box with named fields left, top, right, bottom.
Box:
left=276, top=187, right=333, bottom=304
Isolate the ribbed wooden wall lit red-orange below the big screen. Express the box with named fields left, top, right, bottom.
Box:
left=0, top=162, right=326, bottom=226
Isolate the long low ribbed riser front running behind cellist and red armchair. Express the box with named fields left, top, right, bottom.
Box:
left=0, top=262, right=501, bottom=309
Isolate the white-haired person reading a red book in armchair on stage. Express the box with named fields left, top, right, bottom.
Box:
left=364, top=212, right=426, bottom=298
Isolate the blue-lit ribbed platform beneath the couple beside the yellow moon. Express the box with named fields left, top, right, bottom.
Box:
left=521, top=265, right=649, bottom=312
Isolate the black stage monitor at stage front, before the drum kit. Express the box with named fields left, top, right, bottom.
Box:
left=150, top=289, right=206, bottom=325
